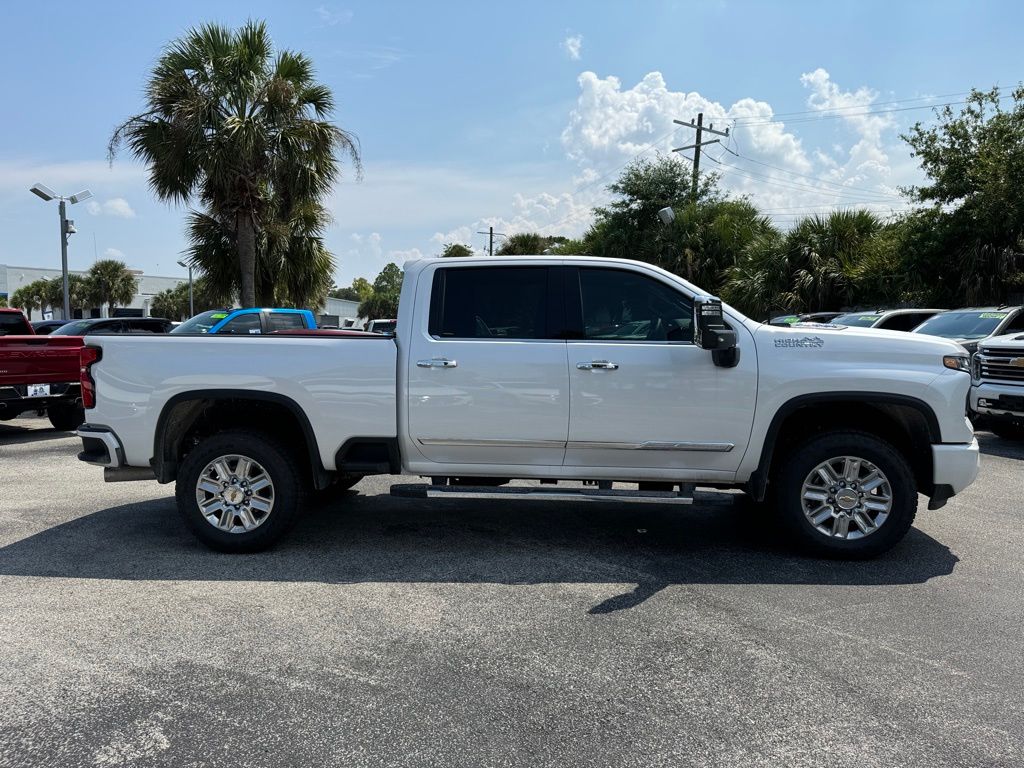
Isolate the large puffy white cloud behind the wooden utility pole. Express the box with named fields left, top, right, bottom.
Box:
left=557, top=69, right=913, bottom=221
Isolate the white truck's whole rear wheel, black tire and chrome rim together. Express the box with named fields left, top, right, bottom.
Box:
left=175, top=431, right=304, bottom=553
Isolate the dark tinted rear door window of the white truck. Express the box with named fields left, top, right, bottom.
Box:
left=430, top=266, right=548, bottom=339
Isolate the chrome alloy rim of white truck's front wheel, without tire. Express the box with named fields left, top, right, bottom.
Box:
left=801, top=456, right=893, bottom=540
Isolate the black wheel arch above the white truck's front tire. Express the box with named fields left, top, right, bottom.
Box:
left=748, top=391, right=942, bottom=501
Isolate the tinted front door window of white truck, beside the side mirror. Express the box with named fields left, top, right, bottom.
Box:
left=580, top=267, right=693, bottom=343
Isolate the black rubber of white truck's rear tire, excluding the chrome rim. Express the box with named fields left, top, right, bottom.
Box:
left=175, top=432, right=302, bottom=552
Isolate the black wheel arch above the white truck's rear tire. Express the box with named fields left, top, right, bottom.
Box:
left=150, top=389, right=330, bottom=488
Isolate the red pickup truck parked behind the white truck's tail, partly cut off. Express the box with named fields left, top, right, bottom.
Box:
left=0, top=309, right=84, bottom=430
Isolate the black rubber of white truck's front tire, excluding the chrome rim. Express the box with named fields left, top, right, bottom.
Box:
left=774, top=432, right=918, bottom=558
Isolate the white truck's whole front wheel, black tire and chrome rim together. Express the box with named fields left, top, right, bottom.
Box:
left=772, top=431, right=918, bottom=559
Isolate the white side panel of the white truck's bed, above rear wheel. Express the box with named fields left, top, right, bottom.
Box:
left=88, top=333, right=397, bottom=470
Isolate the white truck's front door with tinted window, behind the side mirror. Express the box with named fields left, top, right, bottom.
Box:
left=564, top=266, right=757, bottom=473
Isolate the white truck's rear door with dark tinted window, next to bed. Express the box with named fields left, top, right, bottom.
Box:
left=398, top=264, right=569, bottom=466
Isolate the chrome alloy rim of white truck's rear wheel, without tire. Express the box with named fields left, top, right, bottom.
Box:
left=196, top=454, right=273, bottom=534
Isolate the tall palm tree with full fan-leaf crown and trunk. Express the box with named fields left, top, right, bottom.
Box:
left=108, top=22, right=359, bottom=306
